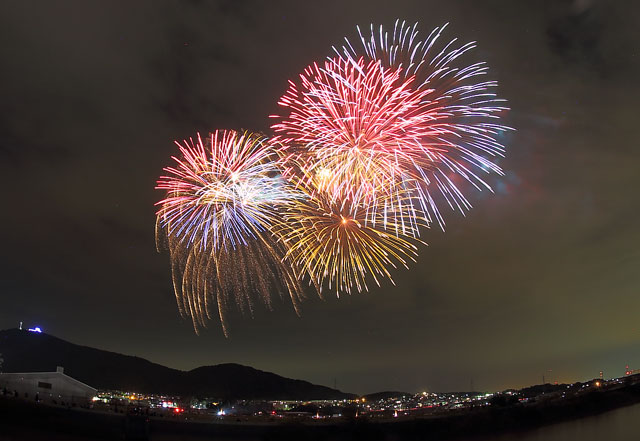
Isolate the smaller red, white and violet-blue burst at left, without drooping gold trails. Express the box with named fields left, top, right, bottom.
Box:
left=157, top=131, right=291, bottom=249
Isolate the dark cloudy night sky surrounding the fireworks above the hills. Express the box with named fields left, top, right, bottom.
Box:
left=0, top=0, right=640, bottom=393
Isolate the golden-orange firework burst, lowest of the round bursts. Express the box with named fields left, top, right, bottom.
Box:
left=278, top=159, right=420, bottom=297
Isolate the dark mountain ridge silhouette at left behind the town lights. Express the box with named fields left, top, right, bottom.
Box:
left=0, top=328, right=355, bottom=400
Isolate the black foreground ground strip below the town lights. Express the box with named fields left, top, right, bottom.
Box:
left=0, top=384, right=640, bottom=441
